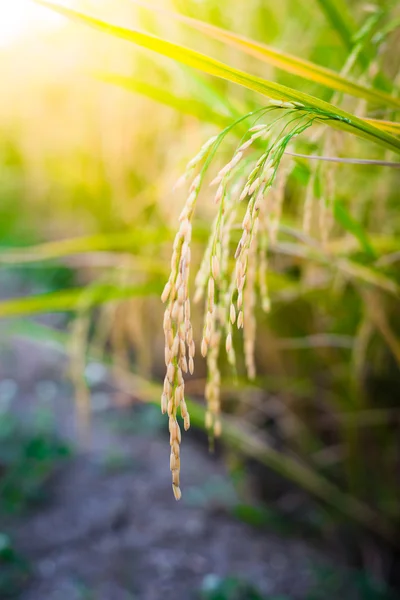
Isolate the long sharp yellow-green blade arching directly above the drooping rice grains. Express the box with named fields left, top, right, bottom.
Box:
left=35, top=0, right=400, bottom=153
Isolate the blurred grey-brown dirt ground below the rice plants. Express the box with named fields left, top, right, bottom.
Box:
left=0, top=340, right=332, bottom=600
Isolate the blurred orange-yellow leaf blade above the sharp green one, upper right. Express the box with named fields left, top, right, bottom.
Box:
left=128, top=0, right=400, bottom=109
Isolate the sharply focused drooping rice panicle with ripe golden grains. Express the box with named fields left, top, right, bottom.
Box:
left=161, top=106, right=318, bottom=499
